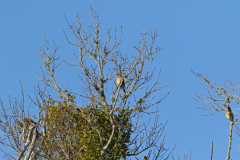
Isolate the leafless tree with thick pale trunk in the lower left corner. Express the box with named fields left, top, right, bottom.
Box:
left=0, top=83, right=47, bottom=160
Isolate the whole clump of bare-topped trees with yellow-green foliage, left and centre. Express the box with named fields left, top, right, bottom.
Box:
left=0, top=8, right=174, bottom=160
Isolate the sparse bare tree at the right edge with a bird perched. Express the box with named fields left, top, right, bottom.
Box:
left=193, top=72, right=240, bottom=160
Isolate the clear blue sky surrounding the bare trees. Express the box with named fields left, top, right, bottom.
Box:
left=0, top=0, right=240, bottom=160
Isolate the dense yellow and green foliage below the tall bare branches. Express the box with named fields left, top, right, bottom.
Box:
left=34, top=94, right=132, bottom=160
